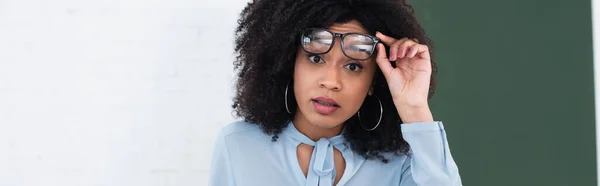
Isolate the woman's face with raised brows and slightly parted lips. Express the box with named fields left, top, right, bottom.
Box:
left=294, top=21, right=377, bottom=128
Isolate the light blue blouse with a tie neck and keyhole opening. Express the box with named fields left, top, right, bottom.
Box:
left=209, top=121, right=462, bottom=186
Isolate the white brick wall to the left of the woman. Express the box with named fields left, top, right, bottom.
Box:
left=0, top=0, right=247, bottom=186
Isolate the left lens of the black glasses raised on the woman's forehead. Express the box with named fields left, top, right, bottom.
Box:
left=301, top=29, right=333, bottom=53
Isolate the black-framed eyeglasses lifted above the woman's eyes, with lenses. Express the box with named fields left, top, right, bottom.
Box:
left=300, top=28, right=379, bottom=60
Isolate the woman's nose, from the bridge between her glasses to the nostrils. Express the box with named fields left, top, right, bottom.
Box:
left=319, top=38, right=348, bottom=91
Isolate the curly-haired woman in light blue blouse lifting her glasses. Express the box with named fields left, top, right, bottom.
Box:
left=210, top=0, right=462, bottom=186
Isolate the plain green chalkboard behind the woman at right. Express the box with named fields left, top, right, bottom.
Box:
left=411, top=0, right=596, bottom=186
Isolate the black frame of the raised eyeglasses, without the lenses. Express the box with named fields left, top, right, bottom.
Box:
left=300, top=28, right=381, bottom=60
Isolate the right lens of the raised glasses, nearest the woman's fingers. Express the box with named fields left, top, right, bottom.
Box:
left=344, top=34, right=375, bottom=59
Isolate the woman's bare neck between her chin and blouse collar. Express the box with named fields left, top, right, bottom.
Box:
left=293, top=112, right=344, bottom=141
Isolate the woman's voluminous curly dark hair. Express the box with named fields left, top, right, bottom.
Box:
left=232, top=0, right=437, bottom=163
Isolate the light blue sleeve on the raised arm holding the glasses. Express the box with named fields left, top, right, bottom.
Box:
left=400, top=122, right=462, bottom=186
